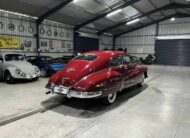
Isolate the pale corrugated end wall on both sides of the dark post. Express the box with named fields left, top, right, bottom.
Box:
left=116, top=18, right=190, bottom=57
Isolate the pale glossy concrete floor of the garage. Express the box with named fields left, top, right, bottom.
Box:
left=0, top=66, right=190, bottom=138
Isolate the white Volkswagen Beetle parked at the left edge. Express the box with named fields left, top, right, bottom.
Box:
left=0, top=53, right=40, bottom=83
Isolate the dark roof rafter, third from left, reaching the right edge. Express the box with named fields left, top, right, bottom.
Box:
left=97, top=3, right=190, bottom=35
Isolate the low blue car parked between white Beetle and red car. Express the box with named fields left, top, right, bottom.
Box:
left=27, top=56, right=65, bottom=77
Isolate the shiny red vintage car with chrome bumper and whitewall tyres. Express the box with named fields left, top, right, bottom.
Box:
left=46, top=51, right=147, bottom=104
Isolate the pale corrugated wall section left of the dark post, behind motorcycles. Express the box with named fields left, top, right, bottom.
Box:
left=116, top=25, right=156, bottom=57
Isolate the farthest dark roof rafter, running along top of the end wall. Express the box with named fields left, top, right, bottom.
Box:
left=114, top=13, right=190, bottom=38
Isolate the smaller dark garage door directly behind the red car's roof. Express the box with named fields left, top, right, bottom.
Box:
left=75, top=36, right=99, bottom=52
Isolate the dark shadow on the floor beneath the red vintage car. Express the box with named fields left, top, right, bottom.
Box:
left=41, top=84, right=148, bottom=118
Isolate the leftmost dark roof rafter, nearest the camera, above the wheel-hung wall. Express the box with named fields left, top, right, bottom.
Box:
left=36, top=0, right=73, bottom=24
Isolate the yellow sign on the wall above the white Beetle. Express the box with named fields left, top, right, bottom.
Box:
left=0, top=36, right=20, bottom=49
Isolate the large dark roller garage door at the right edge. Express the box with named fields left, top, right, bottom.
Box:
left=155, top=40, right=190, bottom=66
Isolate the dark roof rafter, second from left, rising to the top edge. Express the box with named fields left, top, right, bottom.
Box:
left=74, top=0, right=140, bottom=30
